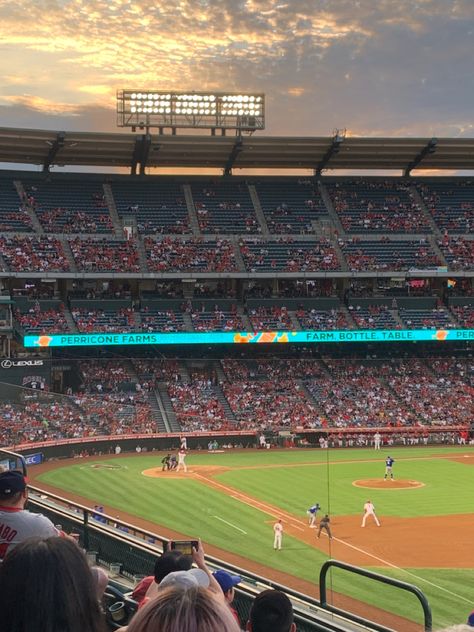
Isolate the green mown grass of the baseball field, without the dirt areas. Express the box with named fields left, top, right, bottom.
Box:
left=39, top=447, right=474, bottom=629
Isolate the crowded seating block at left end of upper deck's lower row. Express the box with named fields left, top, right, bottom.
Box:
left=0, top=235, right=69, bottom=272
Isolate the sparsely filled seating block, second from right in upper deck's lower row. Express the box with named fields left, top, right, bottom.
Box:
left=340, top=238, right=441, bottom=271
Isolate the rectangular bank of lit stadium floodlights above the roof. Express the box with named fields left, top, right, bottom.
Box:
left=117, top=90, right=265, bottom=135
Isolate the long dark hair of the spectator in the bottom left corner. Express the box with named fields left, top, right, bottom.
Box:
left=0, top=538, right=105, bottom=632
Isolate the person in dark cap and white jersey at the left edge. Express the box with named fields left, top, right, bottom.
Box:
left=0, top=470, right=64, bottom=561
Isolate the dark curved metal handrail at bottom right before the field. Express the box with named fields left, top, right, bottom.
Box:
left=319, top=560, right=433, bottom=632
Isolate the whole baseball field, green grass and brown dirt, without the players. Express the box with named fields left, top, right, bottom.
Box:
left=31, top=446, right=474, bottom=630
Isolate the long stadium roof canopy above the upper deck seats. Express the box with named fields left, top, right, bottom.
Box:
left=0, top=128, right=474, bottom=174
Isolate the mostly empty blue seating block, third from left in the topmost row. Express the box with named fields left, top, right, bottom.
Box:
left=111, top=179, right=191, bottom=235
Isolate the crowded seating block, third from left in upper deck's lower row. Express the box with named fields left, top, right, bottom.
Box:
left=145, top=237, right=237, bottom=272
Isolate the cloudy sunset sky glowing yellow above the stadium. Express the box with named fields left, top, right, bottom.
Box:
left=0, top=0, right=474, bottom=136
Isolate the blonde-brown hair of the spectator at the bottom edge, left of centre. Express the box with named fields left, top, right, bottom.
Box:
left=127, top=587, right=240, bottom=632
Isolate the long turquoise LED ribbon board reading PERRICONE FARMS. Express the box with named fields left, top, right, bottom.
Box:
left=23, top=329, right=474, bottom=349
